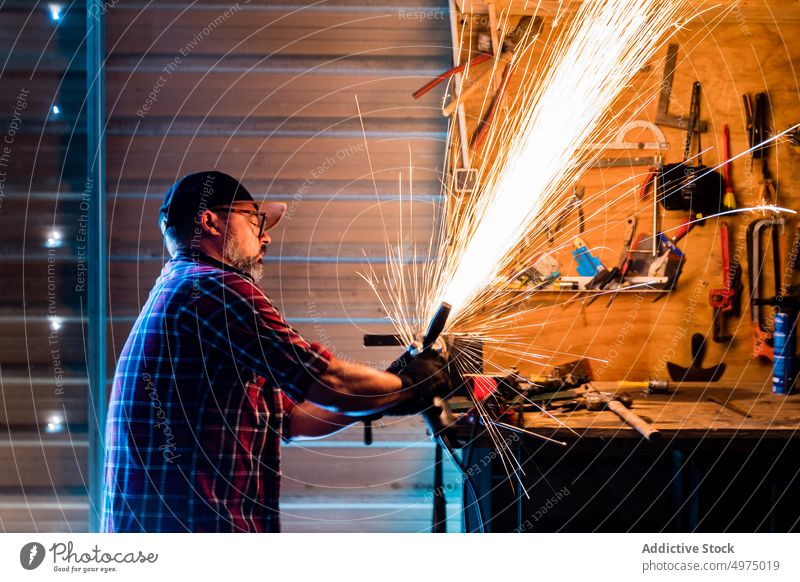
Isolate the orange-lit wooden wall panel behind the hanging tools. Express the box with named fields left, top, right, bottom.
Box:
left=446, top=2, right=800, bottom=387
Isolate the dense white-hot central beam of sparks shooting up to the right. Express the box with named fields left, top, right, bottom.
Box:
left=429, top=0, right=700, bottom=327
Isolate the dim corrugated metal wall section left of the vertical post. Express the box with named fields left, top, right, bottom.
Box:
left=0, top=1, right=88, bottom=531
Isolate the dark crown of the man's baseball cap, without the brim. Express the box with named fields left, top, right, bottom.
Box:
left=159, top=171, right=253, bottom=231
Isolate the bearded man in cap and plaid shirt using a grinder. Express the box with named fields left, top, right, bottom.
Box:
left=102, top=171, right=450, bottom=532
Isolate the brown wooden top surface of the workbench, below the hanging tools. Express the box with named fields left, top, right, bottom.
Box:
left=523, top=382, right=800, bottom=439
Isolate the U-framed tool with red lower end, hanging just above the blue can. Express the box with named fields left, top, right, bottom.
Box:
left=747, top=217, right=785, bottom=360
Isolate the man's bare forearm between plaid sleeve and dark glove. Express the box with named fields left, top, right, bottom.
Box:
left=306, top=358, right=414, bottom=415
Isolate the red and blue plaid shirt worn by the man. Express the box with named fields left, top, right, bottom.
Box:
left=102, top=253, right=331, bottom=532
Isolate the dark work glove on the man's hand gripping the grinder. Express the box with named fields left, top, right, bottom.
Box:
left=383, top=350, right=452, bottom=416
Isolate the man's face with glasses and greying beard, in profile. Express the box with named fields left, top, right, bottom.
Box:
left=220, top=202, right=272, bottom=281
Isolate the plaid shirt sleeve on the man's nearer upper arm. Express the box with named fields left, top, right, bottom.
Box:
left=184, top=272, right=332, bottom=403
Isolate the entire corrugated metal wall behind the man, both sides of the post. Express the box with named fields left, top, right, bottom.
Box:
left=0, top=0, right=457, bottom=531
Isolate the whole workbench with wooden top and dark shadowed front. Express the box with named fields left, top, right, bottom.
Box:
left=456, top=382, right=800, bottom=532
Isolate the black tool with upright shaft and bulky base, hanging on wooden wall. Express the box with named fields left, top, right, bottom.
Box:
left=659, top=81, right=725, bottom=216
